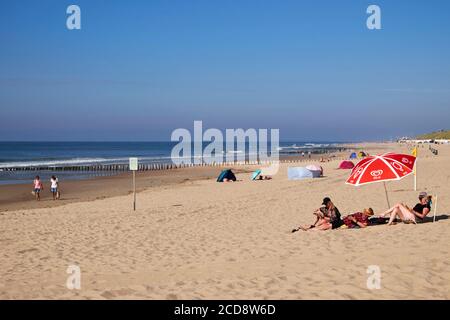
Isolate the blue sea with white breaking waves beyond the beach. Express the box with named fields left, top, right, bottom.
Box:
left=0, top=141, right=340, bottom=184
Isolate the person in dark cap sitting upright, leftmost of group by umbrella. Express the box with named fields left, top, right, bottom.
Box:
left=292, top=197, right=344, bottom=232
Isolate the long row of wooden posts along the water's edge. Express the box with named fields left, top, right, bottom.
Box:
left=0, top=157, right=347, bottom=172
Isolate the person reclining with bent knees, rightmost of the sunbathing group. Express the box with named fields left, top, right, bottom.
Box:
left=380, top=192, right=431, bottom=226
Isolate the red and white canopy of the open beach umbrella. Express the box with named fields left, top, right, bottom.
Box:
left=346, top=153, right=416, bottom=186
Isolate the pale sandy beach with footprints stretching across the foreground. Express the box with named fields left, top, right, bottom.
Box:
left=0, top=143, right=450, bottom=299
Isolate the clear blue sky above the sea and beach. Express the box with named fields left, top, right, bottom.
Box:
left=0, top=0, right=450, bottom=141
